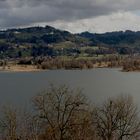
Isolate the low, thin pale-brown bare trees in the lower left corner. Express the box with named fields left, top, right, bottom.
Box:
left=0, top=106, right=41, bottom=140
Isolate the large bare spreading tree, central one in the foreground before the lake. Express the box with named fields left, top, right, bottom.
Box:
left=33, top=85, right=94, bottom=140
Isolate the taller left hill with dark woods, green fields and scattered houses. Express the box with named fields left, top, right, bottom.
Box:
left=0, top=26, right=89, bottom=58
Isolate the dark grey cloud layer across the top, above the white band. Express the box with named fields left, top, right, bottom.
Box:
left=0, top=0, right=140, bottom=28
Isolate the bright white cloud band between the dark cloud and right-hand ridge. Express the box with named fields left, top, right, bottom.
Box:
left=43, top=12, right=140, bottom=33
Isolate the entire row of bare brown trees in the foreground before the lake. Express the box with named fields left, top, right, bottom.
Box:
left=0, top=85, right=140, bottom=140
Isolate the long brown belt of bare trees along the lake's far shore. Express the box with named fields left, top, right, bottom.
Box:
left=17, top=55, right=124, bottom=69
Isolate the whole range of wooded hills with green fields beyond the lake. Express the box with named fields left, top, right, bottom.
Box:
left=0, top=26, right=140, bottom=58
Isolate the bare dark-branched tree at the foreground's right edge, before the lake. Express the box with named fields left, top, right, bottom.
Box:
left=93, top=96, right=140, bottom=140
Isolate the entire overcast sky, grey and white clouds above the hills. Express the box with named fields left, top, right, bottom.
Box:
left=0, top=0, right=140, bottom=33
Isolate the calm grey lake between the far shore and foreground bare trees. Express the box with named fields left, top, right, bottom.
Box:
left=0, top=68, right=140, bottom=106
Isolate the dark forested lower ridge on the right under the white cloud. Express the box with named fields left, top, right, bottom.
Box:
left=78, top=30, right=140, bottom=47
